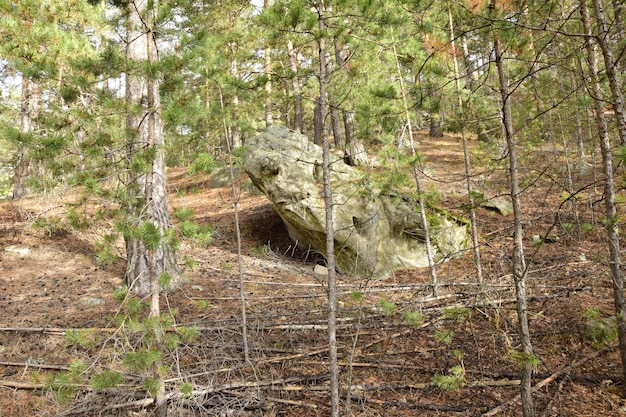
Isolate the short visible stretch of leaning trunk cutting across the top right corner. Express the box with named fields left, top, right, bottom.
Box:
left=593, top=0, right=626, bottom=146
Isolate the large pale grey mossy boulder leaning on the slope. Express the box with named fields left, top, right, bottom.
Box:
left=244, top=125, right=468, bottom=278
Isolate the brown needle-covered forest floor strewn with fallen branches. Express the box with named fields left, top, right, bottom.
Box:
left=0, top=131, right=626, bottom=417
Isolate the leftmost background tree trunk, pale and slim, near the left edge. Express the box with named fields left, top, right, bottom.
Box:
left=13, top=75, right=37, bottom=200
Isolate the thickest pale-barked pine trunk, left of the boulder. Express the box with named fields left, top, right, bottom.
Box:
left=125, top=0, right=181, bottom=296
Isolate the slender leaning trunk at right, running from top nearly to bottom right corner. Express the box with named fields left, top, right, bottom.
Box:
left=580, top=0, right=626, bottom=395
